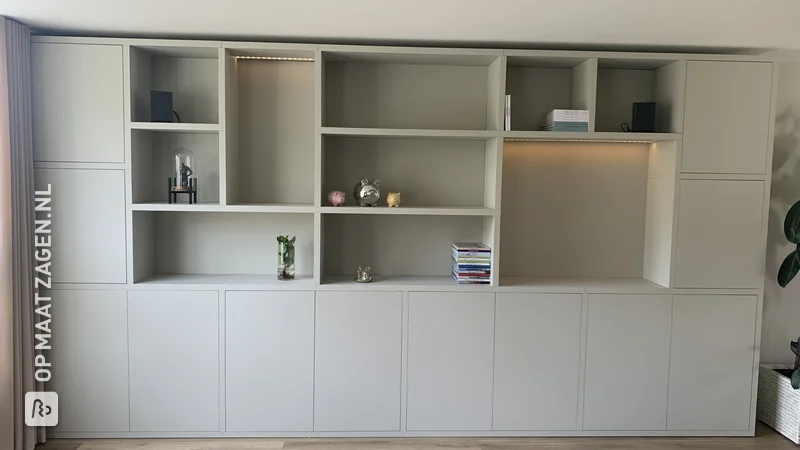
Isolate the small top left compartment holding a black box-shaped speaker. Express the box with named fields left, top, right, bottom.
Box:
left=130, top=46, right=220, bottom=124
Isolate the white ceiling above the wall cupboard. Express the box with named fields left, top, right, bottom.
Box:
left=0, top=0, right=800, bottom=53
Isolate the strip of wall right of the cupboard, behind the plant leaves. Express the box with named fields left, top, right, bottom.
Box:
left=761, top=62, right=800, bottom=364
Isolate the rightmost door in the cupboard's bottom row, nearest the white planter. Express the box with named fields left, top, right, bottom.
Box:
left=667, top=295, right=758, bottom=431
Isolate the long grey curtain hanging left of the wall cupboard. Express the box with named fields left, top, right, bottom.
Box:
left=0, top=18, right=45, bottom=450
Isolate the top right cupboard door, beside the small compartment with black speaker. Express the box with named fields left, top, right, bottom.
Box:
left=681, top=61, right=773, bottom=174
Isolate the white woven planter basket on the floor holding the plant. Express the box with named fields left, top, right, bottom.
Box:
left=756, top=365, right=800, bottom=444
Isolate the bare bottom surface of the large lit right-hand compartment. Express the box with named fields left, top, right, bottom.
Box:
left=499, top=277, right=669, bottom=293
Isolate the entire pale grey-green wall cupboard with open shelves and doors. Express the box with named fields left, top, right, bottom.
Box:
left=36, top=36, right=776, bottom=438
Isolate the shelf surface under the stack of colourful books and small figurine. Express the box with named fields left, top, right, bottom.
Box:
left=320, top=274, right=493, bottom=291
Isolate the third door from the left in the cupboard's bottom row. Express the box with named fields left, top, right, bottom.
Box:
left=225, top=291, right=314, bottom=431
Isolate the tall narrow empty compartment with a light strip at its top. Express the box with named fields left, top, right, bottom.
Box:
left=225, top=44, right=315, bottom=206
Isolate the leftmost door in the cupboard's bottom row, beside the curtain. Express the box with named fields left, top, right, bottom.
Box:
left=48, top=290, right=128, bottom=433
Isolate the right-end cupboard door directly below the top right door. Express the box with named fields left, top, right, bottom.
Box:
left=675, top=180, right=764, bottom=289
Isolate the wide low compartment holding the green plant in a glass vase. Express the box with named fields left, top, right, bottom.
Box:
left=133, top=211, right=314, bottom=284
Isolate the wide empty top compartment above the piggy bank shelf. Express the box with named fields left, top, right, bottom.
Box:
left=321, top=46, right=502, bottom=130
